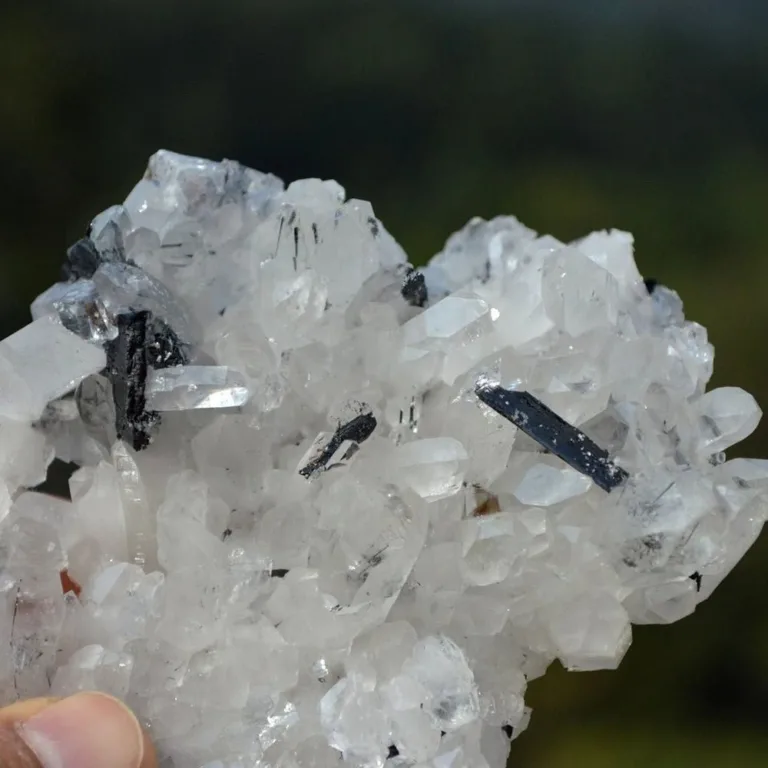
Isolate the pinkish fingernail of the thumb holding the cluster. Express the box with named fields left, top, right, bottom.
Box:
left=18, top=693, right=144, bottom=768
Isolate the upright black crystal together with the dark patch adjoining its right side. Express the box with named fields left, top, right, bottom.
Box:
left=106, top=310, right=187, bottom=451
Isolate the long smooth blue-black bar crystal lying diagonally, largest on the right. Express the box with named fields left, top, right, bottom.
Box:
left=475, top=382, right=629, bottom=491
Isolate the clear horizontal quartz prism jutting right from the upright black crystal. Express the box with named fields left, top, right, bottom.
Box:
left=145, top=365, right=251, bottom=411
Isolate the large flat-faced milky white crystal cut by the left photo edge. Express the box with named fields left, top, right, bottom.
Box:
left=0, top=317, right=106, bottom=421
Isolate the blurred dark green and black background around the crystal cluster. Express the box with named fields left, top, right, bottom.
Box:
left=0, top=0, right=768, bottom=768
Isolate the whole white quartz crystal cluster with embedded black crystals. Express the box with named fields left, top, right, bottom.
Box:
left=0, top=151, right=768, bottom=768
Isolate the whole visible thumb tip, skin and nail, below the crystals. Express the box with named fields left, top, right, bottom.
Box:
left=0, top=693, right=155, bottom=768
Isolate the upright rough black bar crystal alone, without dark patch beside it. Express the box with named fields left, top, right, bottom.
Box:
left=107, top=311, right=159, bottom=451
